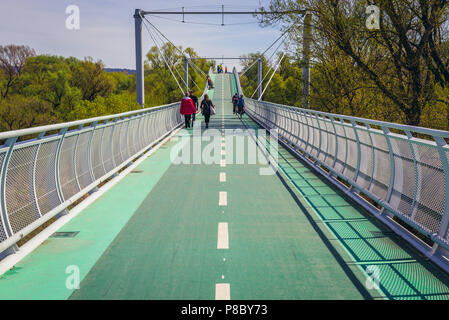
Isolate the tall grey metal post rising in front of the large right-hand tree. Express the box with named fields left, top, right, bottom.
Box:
left=302, top=12, right=312, bottom=109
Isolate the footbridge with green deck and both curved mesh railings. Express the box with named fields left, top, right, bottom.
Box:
left=0, top=8, right=449, bottom=300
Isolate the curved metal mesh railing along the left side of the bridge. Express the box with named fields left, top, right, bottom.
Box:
left=0, top=103, right=183, bottom=252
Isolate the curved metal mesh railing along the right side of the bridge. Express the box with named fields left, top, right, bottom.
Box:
left=234, top=67, right=449, bottom=272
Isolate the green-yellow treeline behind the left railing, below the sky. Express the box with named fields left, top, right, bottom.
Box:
left=0, top=44, right=212, bottom=131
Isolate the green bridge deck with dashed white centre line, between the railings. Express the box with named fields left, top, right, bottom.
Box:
left=0, top=74, right=449, bottom=299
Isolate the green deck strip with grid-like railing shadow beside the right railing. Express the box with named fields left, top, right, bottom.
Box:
left=244, top=117, right=449, bottom=300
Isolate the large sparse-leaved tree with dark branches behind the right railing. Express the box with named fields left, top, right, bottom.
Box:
left=258, top=0, right=449, bottom=125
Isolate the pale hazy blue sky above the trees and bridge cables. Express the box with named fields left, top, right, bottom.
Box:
left=0, top=0, right=280, bottom=69
